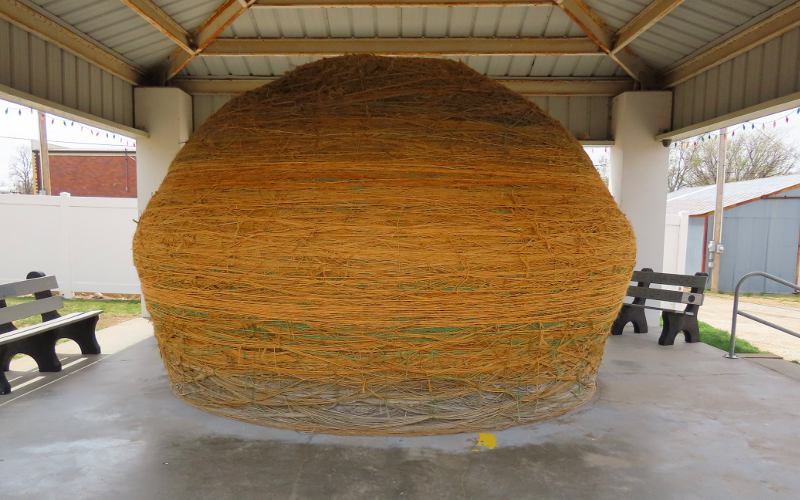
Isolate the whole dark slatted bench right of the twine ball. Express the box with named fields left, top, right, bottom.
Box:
left=611, top=268, right=708, bottom=345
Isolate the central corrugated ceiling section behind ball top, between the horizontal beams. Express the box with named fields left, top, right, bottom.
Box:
left=189, top=5, right=625, bottom=77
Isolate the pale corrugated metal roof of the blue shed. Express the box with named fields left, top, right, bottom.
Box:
left=667, top=174, right=800, bottom=215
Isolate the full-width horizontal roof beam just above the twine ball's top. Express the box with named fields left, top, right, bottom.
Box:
left=203, top=38, right=602, bottom=56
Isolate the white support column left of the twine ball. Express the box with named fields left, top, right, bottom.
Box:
left=133, top=87, right=192, bottom=312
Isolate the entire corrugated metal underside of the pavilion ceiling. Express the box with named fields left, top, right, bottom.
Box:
left=12, top=0, right=791, bottom=85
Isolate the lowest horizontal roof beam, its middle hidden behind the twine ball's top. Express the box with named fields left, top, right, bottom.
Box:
left=172, top=77, right=633, bottom=96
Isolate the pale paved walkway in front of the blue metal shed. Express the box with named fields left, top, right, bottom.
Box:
left=700, top=295, right=800, bottom=361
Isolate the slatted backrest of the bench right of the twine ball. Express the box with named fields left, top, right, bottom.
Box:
left=627, top=268, right=708, bottom=312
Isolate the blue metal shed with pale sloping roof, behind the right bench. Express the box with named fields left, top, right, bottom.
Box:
left=667, top=175, right=800, bottom=293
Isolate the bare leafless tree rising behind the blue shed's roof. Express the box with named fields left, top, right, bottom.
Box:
left=668, top=130, right=800, bottom=191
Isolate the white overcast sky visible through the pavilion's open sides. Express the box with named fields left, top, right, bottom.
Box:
left=0, top=95, right=800, bottom=190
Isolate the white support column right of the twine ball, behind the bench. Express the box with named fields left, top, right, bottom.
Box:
left=609, top=91, right=672, bottom=327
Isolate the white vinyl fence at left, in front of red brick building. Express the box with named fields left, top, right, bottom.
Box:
left=0, top=194, right=140, bottom=297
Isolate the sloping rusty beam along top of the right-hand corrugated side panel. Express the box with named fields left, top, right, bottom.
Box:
left=664, top=2, right=800, bottom=87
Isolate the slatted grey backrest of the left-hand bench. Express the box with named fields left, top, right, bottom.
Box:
left=0, top=271, right=64, bottom=333
